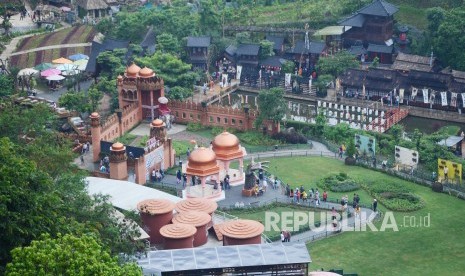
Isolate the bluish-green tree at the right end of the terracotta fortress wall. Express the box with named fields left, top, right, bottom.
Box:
left=255, top=88, right=287, bottom=127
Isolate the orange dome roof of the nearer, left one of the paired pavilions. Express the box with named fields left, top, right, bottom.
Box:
left=186, top=147, right=220, bottom=176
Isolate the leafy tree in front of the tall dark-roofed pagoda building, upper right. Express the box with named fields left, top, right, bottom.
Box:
left=317, top=51, right=359, bottom=78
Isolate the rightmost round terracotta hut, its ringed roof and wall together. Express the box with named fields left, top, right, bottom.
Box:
left=219, top=219, right=265, bottom=245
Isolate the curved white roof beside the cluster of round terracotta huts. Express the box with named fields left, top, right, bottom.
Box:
left=86, top=177, right=182, bottom=210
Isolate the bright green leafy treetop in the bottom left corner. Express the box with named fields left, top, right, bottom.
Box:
left=6, top=235, right=142, bottom=276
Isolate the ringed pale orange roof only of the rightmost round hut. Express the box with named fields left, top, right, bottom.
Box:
left=220, top=219, right=265, bottom=239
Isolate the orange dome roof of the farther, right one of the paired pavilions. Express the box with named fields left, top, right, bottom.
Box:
left=212, top=131, right=244, bottom=160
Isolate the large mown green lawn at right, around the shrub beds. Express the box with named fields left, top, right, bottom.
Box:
left=260, top=157, right=465, bottom=275
